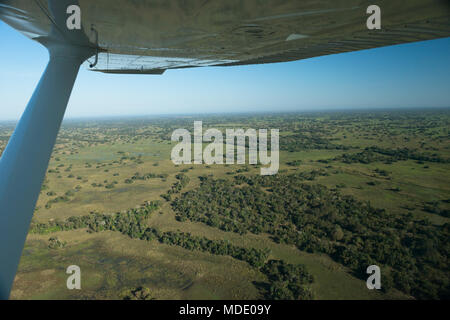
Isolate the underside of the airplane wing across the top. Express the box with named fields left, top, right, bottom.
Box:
left=0, top=0, right=450, bottom=74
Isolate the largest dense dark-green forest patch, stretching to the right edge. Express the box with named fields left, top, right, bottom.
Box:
left=172, top=174, right=450, bottom=298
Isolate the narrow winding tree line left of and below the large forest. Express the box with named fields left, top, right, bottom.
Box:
left=30, top=201, right=313, bottom=300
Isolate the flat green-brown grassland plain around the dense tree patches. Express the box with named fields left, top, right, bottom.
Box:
left=0, top=109, right=450, bottom=299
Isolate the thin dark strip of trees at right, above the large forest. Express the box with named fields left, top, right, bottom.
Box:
left=333, top=146, right=450, bottom=164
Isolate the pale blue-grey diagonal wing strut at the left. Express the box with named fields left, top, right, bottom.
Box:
left=0, top=44, right=91, bottom=299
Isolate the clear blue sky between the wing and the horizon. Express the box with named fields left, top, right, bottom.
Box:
left=0, top=21, right=450, bottom=120
